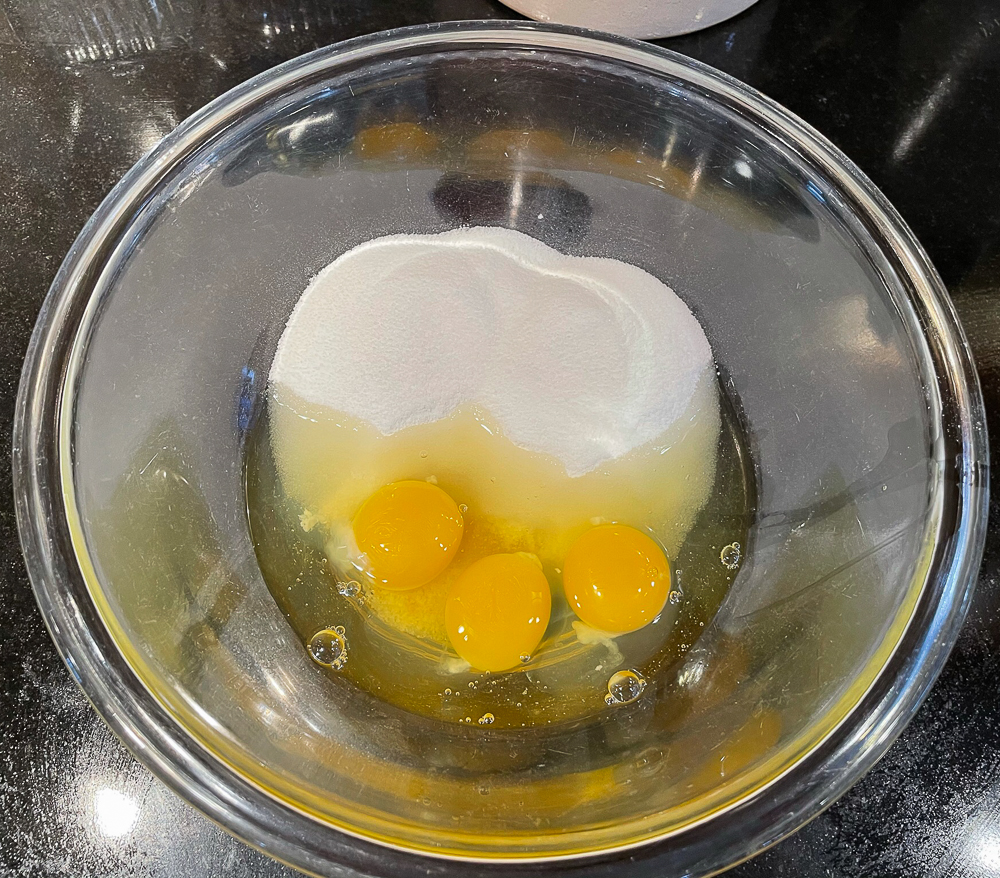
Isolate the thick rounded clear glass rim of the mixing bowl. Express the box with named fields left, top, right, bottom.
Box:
left=12, top=21, right=989, bottom=878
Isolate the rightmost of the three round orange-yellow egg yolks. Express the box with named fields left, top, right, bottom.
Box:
left=563, top=524, right=670, bottom=634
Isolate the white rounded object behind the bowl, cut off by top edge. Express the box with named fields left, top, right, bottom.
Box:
left=503, top=0, right=757, bottom=40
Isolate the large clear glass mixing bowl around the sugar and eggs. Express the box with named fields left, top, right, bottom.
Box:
left=14, top=23, right=987, bottom=878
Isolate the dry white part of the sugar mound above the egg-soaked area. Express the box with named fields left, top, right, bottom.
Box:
left=270, top=228, right=713, bottom=476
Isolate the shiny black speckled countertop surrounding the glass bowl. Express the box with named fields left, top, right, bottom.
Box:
left=0, top=0, right=1000, bottom=878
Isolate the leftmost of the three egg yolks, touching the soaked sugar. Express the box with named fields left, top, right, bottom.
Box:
left=353, top=481, right=463, bottom=591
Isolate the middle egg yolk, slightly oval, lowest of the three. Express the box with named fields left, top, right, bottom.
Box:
left=445, top=552, right=552, bottom=671
